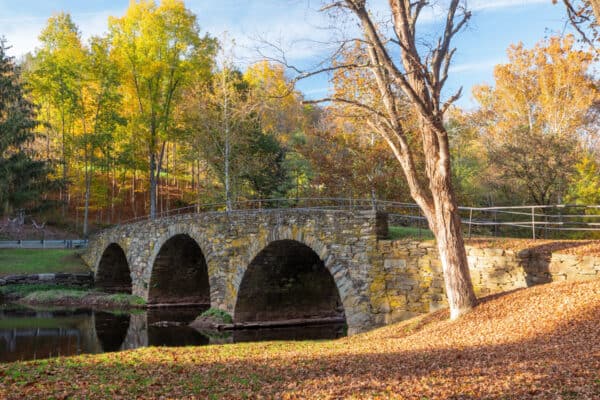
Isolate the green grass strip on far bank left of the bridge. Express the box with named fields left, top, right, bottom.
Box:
left=0, top=249, right=90, bottom=277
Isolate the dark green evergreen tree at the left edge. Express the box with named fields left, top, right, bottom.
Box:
left=0, top=38, right=48, bottom=214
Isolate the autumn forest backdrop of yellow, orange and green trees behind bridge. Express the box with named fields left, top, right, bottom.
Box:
left=0, top=0, right=600, bottom=235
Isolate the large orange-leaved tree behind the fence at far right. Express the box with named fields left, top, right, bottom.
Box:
left=474, top=37, right=598, bottom=205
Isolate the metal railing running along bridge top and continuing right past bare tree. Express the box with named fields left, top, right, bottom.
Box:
left=98, top=197, right=600, bottom=239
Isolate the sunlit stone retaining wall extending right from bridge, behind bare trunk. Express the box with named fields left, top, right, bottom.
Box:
left=378, top=240, right=600, bottom=323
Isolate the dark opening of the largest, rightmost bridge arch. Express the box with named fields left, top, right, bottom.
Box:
left=234, top=240, right=345, bottom=322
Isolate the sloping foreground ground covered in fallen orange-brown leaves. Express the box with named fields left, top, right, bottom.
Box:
left=0, top=280, right=600, bottom=400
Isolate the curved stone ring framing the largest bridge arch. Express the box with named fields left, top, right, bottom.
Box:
left=230, top=226, right=368, bottom=333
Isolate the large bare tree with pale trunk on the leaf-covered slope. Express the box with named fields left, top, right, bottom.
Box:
left=288, top=0, right=476, bottom=318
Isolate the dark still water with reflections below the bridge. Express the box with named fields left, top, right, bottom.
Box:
left=0, top=304, right=345, bottom=362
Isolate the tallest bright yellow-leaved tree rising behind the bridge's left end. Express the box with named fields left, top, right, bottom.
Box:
left=109, top=0, right=214, bottom=218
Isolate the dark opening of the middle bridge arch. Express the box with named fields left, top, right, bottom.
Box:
left=148, top=234, right=210, bottom=305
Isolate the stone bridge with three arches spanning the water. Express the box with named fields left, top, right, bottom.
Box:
left=84, top=209, right=389, bottom=334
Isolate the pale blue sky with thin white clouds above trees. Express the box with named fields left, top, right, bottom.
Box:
left=0, top=0, right=580, bottom=108
